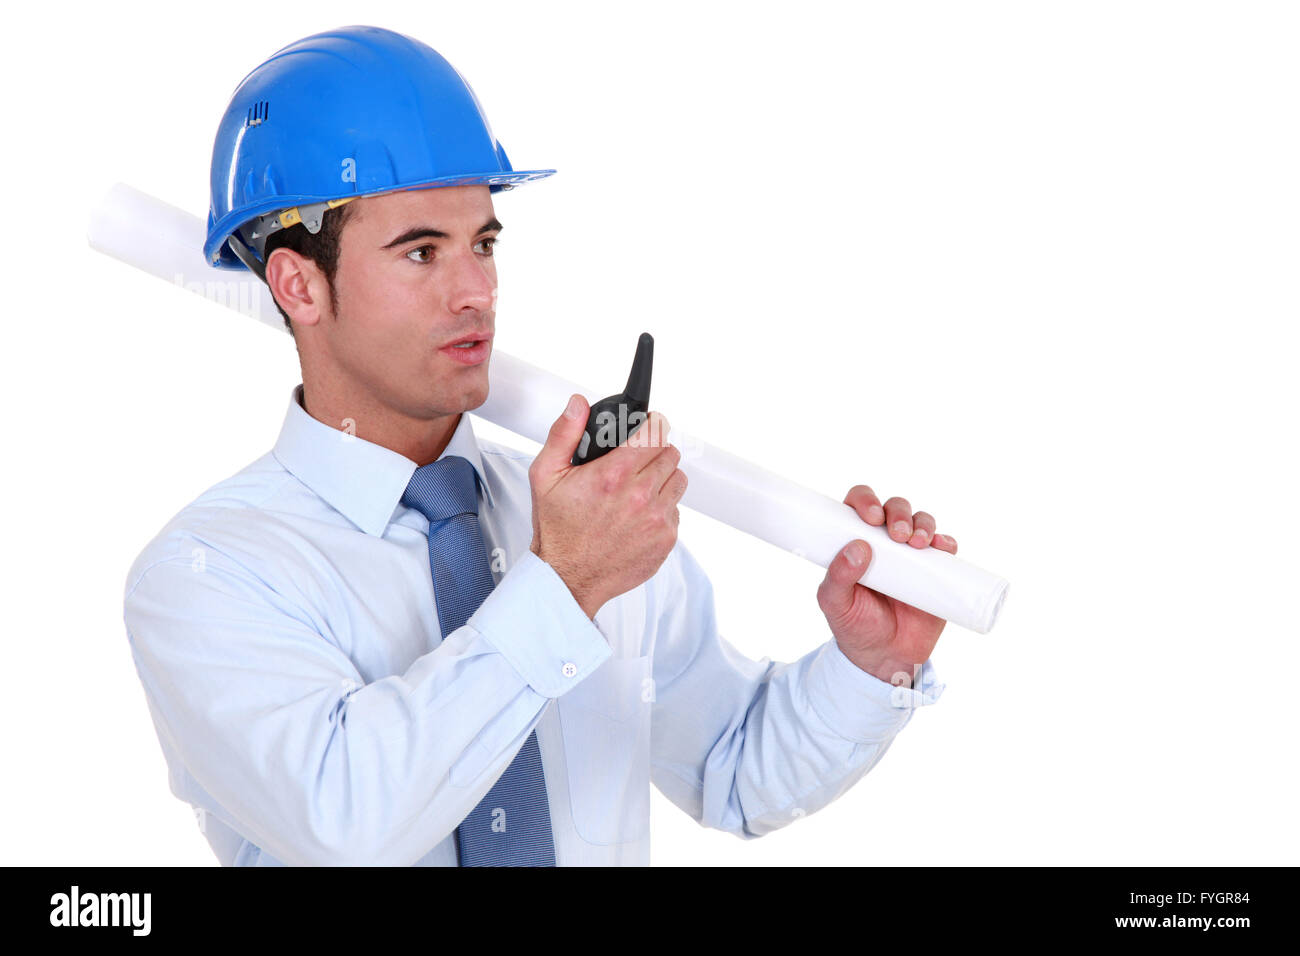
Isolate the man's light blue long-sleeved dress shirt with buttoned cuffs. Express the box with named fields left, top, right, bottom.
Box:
left=125, top=386, right=943, bottom=866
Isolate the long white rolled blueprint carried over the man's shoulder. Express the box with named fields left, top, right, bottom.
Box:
left=87, top=183, right=1010, bottom=633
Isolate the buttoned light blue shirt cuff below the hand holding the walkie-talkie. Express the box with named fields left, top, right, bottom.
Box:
left=465, top=550, right=614, bottom=697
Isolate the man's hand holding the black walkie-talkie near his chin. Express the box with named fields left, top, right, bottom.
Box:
left=528, top=394, right=686, bottom=618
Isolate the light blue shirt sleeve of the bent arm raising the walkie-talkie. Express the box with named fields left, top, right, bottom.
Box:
left=125, top=551, right=611, bottom=865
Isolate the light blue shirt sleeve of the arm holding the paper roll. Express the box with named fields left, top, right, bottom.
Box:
left=651, top=540, right=944, bottom=839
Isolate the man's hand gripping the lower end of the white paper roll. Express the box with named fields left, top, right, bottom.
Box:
left=816, top=485, right=957, bottom=687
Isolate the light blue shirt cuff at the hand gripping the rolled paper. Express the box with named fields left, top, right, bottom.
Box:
left=807, top=639, right=945, bottom=743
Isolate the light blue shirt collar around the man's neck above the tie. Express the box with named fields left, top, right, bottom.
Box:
left=272, top=385, right=493, bottom=537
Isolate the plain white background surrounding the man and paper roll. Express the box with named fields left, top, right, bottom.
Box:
left=0, top=0, right=1300, bottom=865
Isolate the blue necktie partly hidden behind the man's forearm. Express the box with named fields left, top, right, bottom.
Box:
left=402, top=455, right=555, bottom=866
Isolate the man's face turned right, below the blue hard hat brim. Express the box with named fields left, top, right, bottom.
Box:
left=317, top=186, right=501, bottom=420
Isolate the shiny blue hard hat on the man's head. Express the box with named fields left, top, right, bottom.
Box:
left=203, top=26, right=555, bottom=272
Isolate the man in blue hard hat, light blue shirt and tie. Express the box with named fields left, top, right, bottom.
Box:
left=125, top=27, right=956, bottom=865
